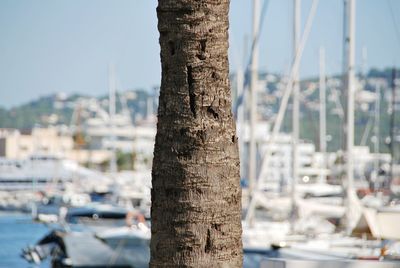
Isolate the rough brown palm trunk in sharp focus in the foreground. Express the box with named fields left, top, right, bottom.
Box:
left=150, top=0, right=242, bottom=267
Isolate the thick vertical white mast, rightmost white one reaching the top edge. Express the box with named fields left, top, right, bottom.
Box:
left=346, top=0, right=356, bottom=231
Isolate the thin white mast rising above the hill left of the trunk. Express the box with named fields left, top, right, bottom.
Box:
left=108, top=64, right=117, bottom=173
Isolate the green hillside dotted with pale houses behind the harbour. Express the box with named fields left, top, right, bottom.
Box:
left=0, top=69, right=400, bottom=155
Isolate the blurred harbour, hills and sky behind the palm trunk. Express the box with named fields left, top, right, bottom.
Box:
left=0, top=0, right=400, bottom=267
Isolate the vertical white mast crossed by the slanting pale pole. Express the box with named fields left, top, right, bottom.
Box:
left=291, top=0, right=301, bottom=225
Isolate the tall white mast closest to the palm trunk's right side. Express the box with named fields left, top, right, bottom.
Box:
left=249, top=0, right=260, bottom=198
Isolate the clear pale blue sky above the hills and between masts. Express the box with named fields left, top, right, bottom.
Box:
left=0, top=0, right=400, bottom=108
